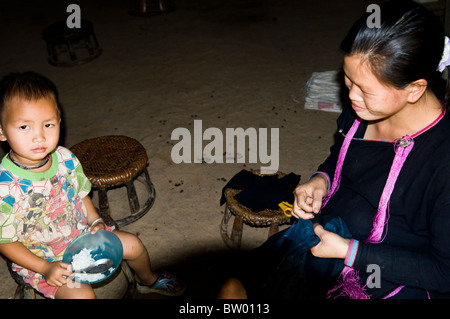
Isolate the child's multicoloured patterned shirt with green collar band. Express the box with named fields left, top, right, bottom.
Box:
left=0, top=147, right=91, bottom=281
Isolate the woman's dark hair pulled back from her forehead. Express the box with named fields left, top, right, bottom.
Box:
left=341, top=0, right=449, bottom=107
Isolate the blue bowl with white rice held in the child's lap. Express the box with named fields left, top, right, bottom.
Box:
left=62, top=230, right=123, bottom=284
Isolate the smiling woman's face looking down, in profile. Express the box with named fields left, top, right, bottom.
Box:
left=344, top=55, right=409, bottom=121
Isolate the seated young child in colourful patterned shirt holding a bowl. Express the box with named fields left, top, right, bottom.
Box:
left=0, top=72, right=185, bottom=298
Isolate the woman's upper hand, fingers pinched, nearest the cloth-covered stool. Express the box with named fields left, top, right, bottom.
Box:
left=292, top=174, right=328, bottom=219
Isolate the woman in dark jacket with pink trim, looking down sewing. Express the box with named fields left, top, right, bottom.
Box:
left=221, top=1, right=450, bottom=298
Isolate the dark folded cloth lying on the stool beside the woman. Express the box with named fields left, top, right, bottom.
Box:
left=220, top=170, right=300, bottom=212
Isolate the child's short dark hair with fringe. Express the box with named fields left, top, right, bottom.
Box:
left=0, top=71, right=61, bottom=121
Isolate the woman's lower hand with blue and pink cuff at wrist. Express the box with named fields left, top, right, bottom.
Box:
left=311, top=223, right=350, bottom=259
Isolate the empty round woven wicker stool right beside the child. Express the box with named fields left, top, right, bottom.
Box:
left=71, top=135, right=156, bottom=226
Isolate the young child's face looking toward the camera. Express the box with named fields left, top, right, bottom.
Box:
left=0, top=98, right=61, bottom=165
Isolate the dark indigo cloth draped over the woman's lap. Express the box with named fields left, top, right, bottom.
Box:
left=240, top=217, right=351, bottom=299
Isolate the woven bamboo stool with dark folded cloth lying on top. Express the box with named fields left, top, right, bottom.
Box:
left=220, top=170, right=290, bottom=249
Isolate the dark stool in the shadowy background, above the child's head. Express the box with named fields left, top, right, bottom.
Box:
left=42, top=20, right=102, bottom=66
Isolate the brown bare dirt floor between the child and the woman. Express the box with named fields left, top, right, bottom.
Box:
left=0, top=0, right=374, bottom=300
